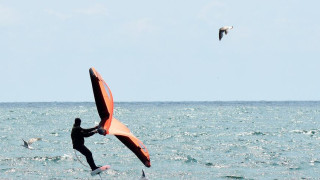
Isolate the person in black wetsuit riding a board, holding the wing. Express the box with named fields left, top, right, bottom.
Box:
left=71, top=118, right=99, bottom=171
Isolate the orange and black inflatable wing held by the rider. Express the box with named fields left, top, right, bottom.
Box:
left=89, top=68, right=151, bottom=167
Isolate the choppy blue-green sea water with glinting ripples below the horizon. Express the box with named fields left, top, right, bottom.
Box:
left=0, top=102, right=320, bottom=179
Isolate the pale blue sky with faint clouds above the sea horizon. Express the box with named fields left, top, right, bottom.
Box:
left=0, top=0, right=320, bottom=102
